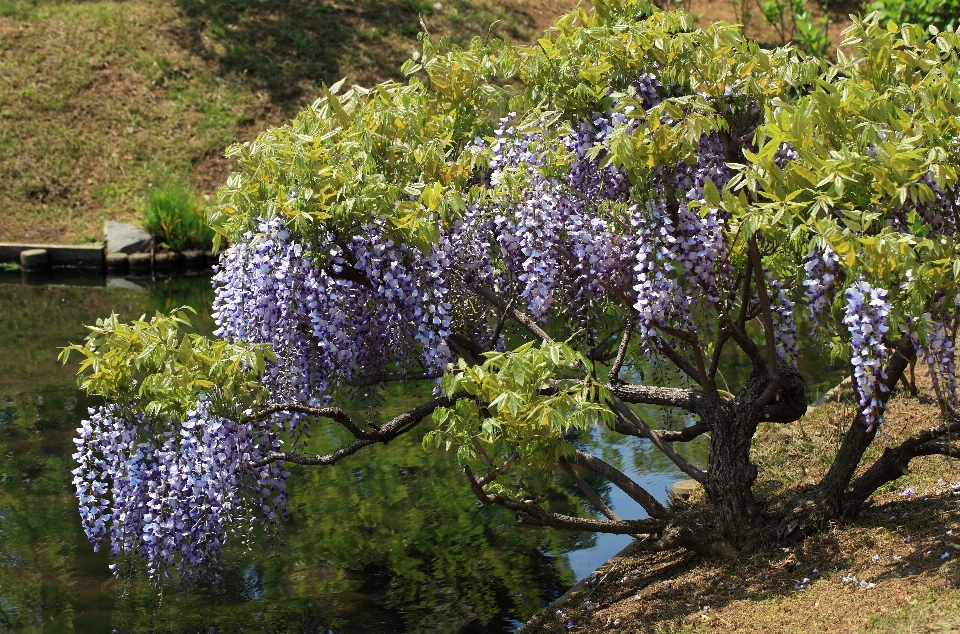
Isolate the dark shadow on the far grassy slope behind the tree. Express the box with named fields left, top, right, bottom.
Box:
left=176, top=0, right=435, bottom=105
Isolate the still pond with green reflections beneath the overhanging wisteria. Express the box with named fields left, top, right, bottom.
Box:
left=0, top=276, right=842, bottom=634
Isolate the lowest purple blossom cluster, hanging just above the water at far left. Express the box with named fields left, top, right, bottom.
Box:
left=73, top=400, right=289, bottom=577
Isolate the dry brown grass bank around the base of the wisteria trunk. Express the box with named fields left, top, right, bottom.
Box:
left=525, top=366, right=960, bottom=634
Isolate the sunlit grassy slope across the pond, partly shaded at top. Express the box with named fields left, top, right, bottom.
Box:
left=0, top=0, right=575, bottom=243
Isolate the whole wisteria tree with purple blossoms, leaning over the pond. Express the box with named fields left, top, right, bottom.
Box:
left=65, top=0, right=960, bottom=574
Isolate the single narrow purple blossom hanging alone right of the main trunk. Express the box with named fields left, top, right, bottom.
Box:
left=843, top=279, right=891, bottom=429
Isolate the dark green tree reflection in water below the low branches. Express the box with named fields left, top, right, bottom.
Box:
left=278, top=388, right=582, bottom=632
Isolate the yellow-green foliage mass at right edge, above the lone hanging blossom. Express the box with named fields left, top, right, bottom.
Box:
left=728, top=17, right=960, bottom=344
